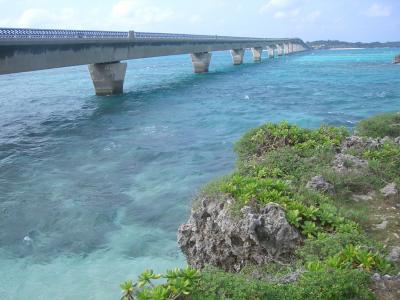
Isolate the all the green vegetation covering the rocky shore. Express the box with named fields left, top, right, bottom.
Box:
left=123, top=114, right=400, bottom=300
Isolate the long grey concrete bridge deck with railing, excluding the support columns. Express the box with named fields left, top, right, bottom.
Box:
left=0, top=28, right=304, bottom=74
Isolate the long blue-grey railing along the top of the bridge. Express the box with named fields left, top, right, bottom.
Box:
left=0, top=28, right=289, bottom=41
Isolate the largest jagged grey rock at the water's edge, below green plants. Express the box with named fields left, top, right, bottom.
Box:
left=178, top=197, right=302, bottom=271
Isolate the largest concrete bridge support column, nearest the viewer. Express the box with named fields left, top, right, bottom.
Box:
left=89, top=62, right=127, bottom=96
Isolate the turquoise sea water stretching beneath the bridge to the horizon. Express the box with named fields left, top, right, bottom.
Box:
left=0, top=49, right=400, bottom=300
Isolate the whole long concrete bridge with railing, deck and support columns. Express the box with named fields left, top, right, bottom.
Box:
left=0, top=28, right=308, bottom=95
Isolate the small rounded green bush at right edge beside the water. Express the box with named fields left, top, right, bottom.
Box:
left=356, top=113, right=400, bottom=138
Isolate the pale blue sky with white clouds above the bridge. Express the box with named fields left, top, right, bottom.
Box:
left=0, top=0, right=400, bottom=42
